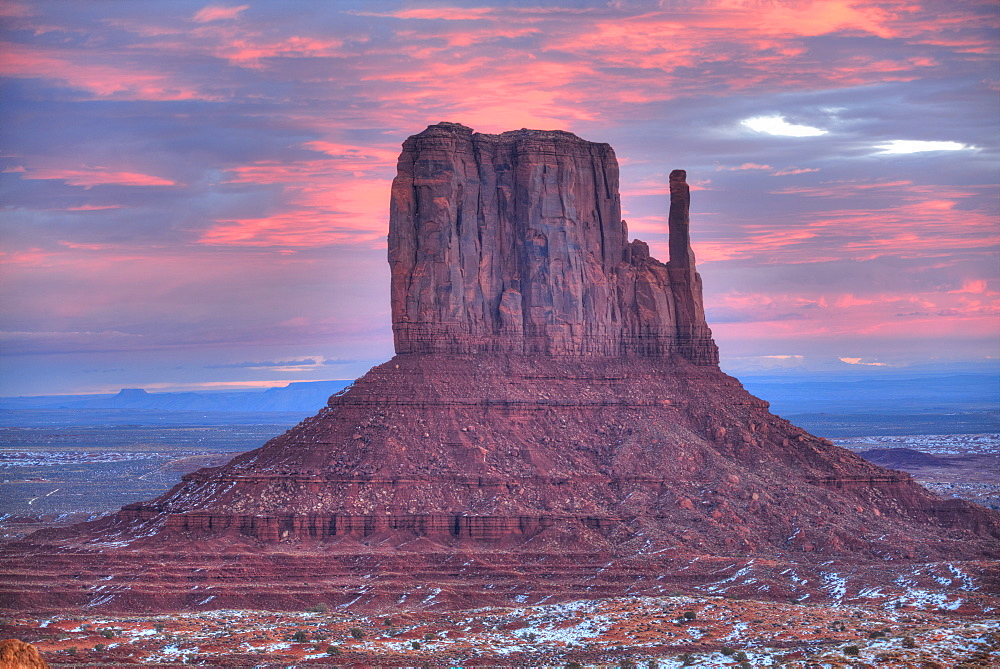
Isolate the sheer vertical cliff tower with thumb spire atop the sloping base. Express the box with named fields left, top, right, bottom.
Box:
left=389, top=123, right=718, bottom=365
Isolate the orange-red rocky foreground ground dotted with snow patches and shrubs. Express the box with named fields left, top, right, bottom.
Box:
left=0, top=596, right=1000, bottom=668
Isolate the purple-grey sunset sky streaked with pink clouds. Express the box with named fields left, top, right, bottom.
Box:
left=0, top=0, right=1000, bottom=396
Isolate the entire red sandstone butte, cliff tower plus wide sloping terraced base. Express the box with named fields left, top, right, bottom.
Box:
left=0, top=123, right=1000, bottom=612
